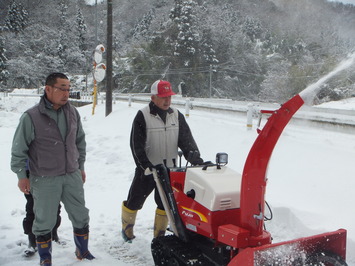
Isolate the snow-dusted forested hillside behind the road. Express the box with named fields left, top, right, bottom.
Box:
left=0, top=0, right=355, bottom=102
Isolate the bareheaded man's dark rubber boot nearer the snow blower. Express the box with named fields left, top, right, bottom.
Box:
left=74, top=226, right=95, bottom=260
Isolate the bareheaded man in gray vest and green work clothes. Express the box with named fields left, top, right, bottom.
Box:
left=11, top=73, right=94, bottom=265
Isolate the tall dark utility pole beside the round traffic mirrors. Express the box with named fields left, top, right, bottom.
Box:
left=106, top=0, right=113, bottom=116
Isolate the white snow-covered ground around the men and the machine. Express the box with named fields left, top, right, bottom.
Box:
left=0, top=95, right=355, bottom=266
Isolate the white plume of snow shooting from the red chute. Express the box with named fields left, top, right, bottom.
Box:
left=299, top=53, right=355, bottom=105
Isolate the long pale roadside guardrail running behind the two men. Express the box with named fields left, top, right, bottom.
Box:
left=6, top=92, right=355, bottom=132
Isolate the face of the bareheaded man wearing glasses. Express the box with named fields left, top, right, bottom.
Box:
left=45, top=78, right=70, bottom=110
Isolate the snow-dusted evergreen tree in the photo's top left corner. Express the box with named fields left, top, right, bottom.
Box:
left=5, top=1, right=28, bottom=34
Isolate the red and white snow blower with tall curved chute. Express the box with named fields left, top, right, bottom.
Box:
left=151, top=95, right=346, bottom=266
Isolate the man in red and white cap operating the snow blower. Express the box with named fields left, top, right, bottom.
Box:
left=122, top=80, right=203, bottom=242
